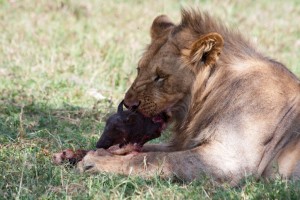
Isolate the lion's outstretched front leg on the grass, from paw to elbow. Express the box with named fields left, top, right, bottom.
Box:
left=78, top=147, right=241, bottom=184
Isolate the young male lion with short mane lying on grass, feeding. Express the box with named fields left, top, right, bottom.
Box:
left=78, top=10, right=300, bottom=184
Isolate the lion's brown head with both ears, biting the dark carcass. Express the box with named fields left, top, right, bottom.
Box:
left=124, top=10, right=223, bottom=123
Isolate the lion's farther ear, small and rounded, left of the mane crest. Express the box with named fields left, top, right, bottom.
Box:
left=151, top=15, right=174, bottom=40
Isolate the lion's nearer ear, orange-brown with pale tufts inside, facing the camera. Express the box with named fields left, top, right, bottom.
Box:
left=181, top=33, right=224, bottom=72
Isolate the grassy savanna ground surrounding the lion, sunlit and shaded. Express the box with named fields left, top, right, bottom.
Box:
left=0, top=0, right=300, bottom=199
